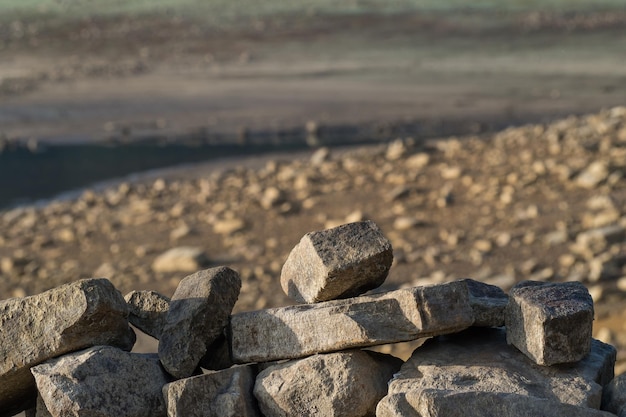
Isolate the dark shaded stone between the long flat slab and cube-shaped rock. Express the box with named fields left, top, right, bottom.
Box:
left=462, top=278, right=509, bottom=327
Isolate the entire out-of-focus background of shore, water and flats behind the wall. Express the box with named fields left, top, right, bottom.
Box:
left=0, top=0, right=626, bottom=373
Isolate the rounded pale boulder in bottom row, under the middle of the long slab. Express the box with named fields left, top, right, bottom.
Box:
left=254, top=350, right=402, bottom=417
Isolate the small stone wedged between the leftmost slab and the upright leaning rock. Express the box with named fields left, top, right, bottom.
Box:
left=124, top=291, right=170, bottom=340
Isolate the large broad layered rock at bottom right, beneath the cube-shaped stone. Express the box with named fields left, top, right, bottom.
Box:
left=377, top=328, right=616, bottom=417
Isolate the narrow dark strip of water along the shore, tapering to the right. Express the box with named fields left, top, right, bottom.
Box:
left=0, top=111, right=572, bottom=209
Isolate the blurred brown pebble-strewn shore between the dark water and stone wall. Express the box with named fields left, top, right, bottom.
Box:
left=0, top=107, right=626, bottom=374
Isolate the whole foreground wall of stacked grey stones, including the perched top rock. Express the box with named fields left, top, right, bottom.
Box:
left=0, top=221, right=626, bottom=417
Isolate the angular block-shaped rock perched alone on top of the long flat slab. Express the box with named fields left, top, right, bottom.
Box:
left=280, top=220, right=393, bottom=303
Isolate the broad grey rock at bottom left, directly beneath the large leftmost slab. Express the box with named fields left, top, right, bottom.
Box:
left=31, top=346, right=170, bottom=417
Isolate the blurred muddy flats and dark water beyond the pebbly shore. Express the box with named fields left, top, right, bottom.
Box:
left=0, top=0, right=626, bottom=207
